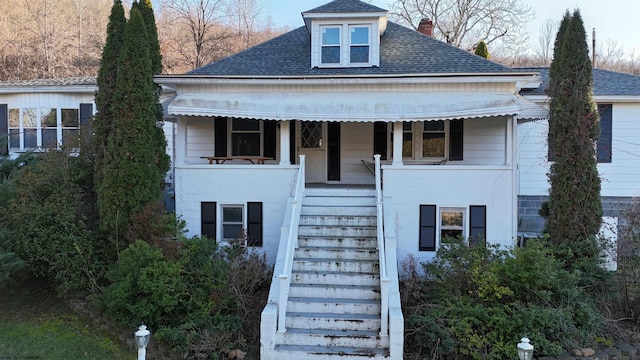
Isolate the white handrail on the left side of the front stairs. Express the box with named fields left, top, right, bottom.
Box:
left=278, top=155, right=305, bottom=332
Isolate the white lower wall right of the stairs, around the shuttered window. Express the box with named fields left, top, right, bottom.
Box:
left=383, top=166, right=516, bottom=261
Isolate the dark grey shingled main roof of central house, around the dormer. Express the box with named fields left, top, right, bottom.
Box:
left=187, top=21, right=521, bottom=77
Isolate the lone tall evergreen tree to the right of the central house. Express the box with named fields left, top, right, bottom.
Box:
left=544, top=10, right=602, bottom=257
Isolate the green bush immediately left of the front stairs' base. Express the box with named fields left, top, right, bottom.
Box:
left=101, top=238, right=271, bottom=357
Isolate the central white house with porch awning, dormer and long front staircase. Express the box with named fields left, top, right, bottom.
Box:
left=156, top=0, right=544, bottom=360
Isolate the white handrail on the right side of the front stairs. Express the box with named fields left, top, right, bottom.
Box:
left=373, top=154, right=389, bottom=336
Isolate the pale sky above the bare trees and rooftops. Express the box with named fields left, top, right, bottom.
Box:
left=264, top=0, right=640, bottom=56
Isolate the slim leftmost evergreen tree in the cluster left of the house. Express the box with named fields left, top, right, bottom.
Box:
left=92, top=0, right=127, bottom=195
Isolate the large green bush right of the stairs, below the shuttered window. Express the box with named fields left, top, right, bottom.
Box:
left=401, top=240, right=603, bottom=359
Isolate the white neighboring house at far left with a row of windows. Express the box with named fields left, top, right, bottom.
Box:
left=0, top=77, right=97, bottom=155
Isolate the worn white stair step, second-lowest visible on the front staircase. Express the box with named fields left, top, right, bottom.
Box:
left=282, top=328, right=389, bottom=348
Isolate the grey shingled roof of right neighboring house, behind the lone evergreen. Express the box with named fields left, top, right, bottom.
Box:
left=518, top=68, right=640, bottom=96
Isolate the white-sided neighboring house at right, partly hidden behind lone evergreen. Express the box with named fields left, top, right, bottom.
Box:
left=518, top=68, right=640, bottom=237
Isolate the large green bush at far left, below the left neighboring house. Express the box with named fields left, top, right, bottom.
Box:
left=2, top=151, right=110, bottom=292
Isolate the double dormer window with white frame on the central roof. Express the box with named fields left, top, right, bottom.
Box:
left=311, top=21, right=380, bottom=68
